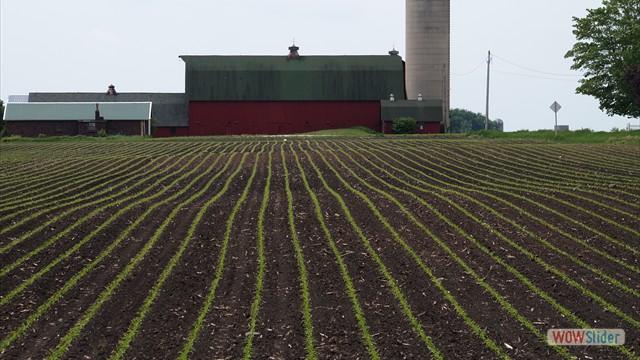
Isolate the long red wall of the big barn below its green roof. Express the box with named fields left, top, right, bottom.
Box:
left=189, top=101, right=381, bottom=135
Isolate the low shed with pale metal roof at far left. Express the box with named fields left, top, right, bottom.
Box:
left=4, top=102, right=151, bottom=137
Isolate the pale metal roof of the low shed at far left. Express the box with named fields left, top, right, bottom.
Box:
left=4, top=102, right=151, bottom=121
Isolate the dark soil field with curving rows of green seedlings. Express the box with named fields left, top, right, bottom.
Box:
left=0, top=137, right=640, bottom=359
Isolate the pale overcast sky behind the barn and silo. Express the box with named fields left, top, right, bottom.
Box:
left=0, top=0, right=639, bottom=131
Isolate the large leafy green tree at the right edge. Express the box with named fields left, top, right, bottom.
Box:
left=565, top=0, right=640, bottom=117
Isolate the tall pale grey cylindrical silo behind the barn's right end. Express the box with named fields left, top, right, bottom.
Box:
left=405, top=0, right=451, bottom=129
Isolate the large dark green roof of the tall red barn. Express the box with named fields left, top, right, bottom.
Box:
left=180, top=55, right=404, bottom=101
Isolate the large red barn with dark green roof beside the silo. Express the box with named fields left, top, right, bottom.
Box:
left=180, top=45, right=442, bottom=135
